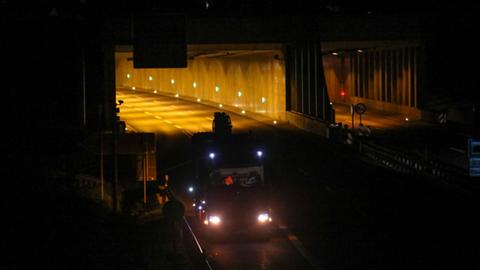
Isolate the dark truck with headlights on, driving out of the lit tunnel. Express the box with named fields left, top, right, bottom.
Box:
left=190, top=112, right=273, bottom=239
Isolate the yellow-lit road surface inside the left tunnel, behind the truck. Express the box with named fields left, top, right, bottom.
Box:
left=117, top=89, right=274, bottom=136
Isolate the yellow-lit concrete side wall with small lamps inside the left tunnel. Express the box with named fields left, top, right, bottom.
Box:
left=115, top=51, right=286, bottom=121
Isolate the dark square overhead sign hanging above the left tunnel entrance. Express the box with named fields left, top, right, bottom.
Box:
left=133, top=14, right=187, bottom=68
